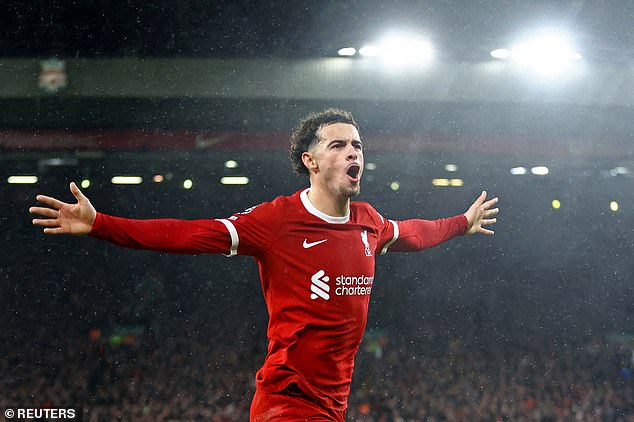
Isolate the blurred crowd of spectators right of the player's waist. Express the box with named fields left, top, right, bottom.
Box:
left=348, top=328, right=634, bottom=421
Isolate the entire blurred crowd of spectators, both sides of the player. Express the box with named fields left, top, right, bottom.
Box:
left=0, top=312, right=634, bottom=422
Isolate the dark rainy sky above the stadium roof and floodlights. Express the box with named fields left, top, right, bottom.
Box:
left=0, top=0, right=634, bottom=62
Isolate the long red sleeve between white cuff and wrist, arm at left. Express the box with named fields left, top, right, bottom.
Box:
left=89, top=212, right=231, bottom=254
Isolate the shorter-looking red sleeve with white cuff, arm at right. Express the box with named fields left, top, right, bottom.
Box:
left=386, top=214, right=467, bottom=252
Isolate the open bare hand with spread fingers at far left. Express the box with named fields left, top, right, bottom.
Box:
left=29, top=182, right=97, bottom=235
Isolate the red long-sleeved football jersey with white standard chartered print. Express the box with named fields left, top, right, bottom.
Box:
left=91, top=189, right=467, bottom=410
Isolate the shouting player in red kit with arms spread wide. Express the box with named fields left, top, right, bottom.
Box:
left=30, top=109, right=498, bottom=422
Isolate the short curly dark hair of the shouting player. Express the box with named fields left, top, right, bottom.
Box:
left=290, top=108, right=359, bottom=176
